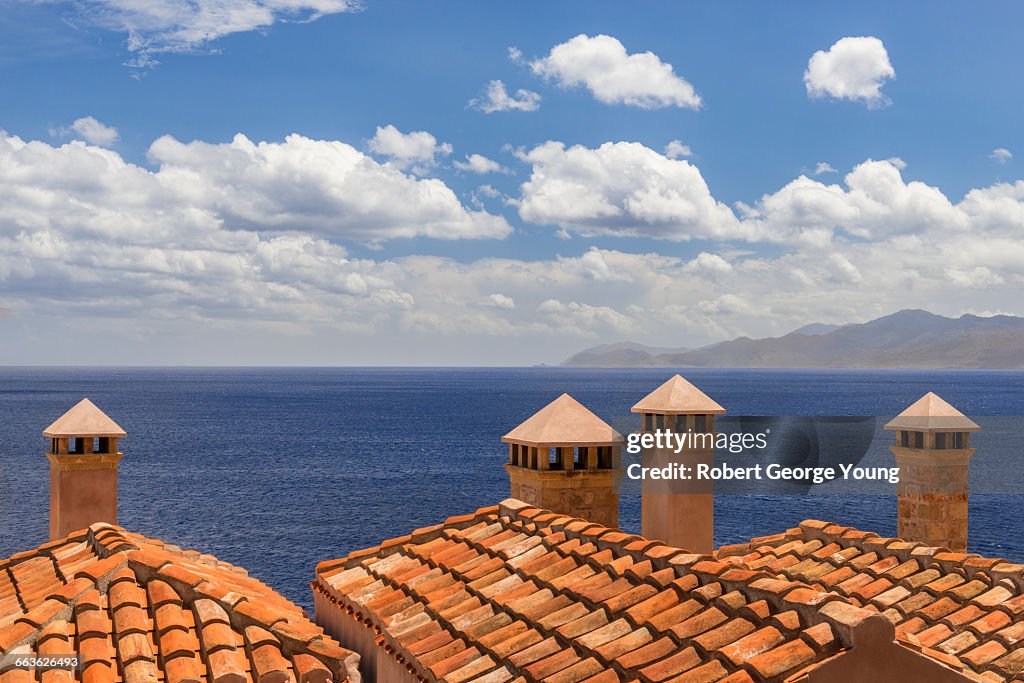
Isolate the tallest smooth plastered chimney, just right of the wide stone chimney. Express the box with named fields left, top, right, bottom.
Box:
left=633, top=375, right=725, bottom=553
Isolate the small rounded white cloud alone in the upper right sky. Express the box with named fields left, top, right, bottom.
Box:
left=804, top=36, right=896, bottom=108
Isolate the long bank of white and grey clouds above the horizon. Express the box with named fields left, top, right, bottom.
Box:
left=0, top=127, right=1024, bottom=364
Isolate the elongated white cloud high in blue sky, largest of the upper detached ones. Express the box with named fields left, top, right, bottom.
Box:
left=529, top=34, right=701, bottom=110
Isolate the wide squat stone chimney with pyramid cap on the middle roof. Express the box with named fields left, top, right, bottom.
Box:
left=502, top=393, right=624, bottom=528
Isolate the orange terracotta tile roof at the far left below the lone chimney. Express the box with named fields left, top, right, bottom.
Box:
left=0, top=524, right=359, bottom=683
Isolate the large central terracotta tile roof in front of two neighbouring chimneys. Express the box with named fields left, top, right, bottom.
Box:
left=313, top=500, right=999, bottom=683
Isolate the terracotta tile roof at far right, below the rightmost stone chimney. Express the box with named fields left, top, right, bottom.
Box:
left=716, top=520, right=1024, bottom=681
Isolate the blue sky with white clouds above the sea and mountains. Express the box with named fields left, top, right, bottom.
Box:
left=0, top=0, right=1024, bottom=365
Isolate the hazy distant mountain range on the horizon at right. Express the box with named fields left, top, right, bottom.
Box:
left=561, top=310, right=1024, bottom=369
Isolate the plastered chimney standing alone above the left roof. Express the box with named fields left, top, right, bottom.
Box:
left=43, top=398, right=127, bottom=541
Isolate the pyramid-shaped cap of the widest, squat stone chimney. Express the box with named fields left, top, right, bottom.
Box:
left=502, top=393, right=624, bottom=449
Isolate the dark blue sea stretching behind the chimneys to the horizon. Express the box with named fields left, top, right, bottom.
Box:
left=0, top=368, right=1024, bottom=607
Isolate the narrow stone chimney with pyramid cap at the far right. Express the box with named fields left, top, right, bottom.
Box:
left=885, top=392, right=981, bottom=551
